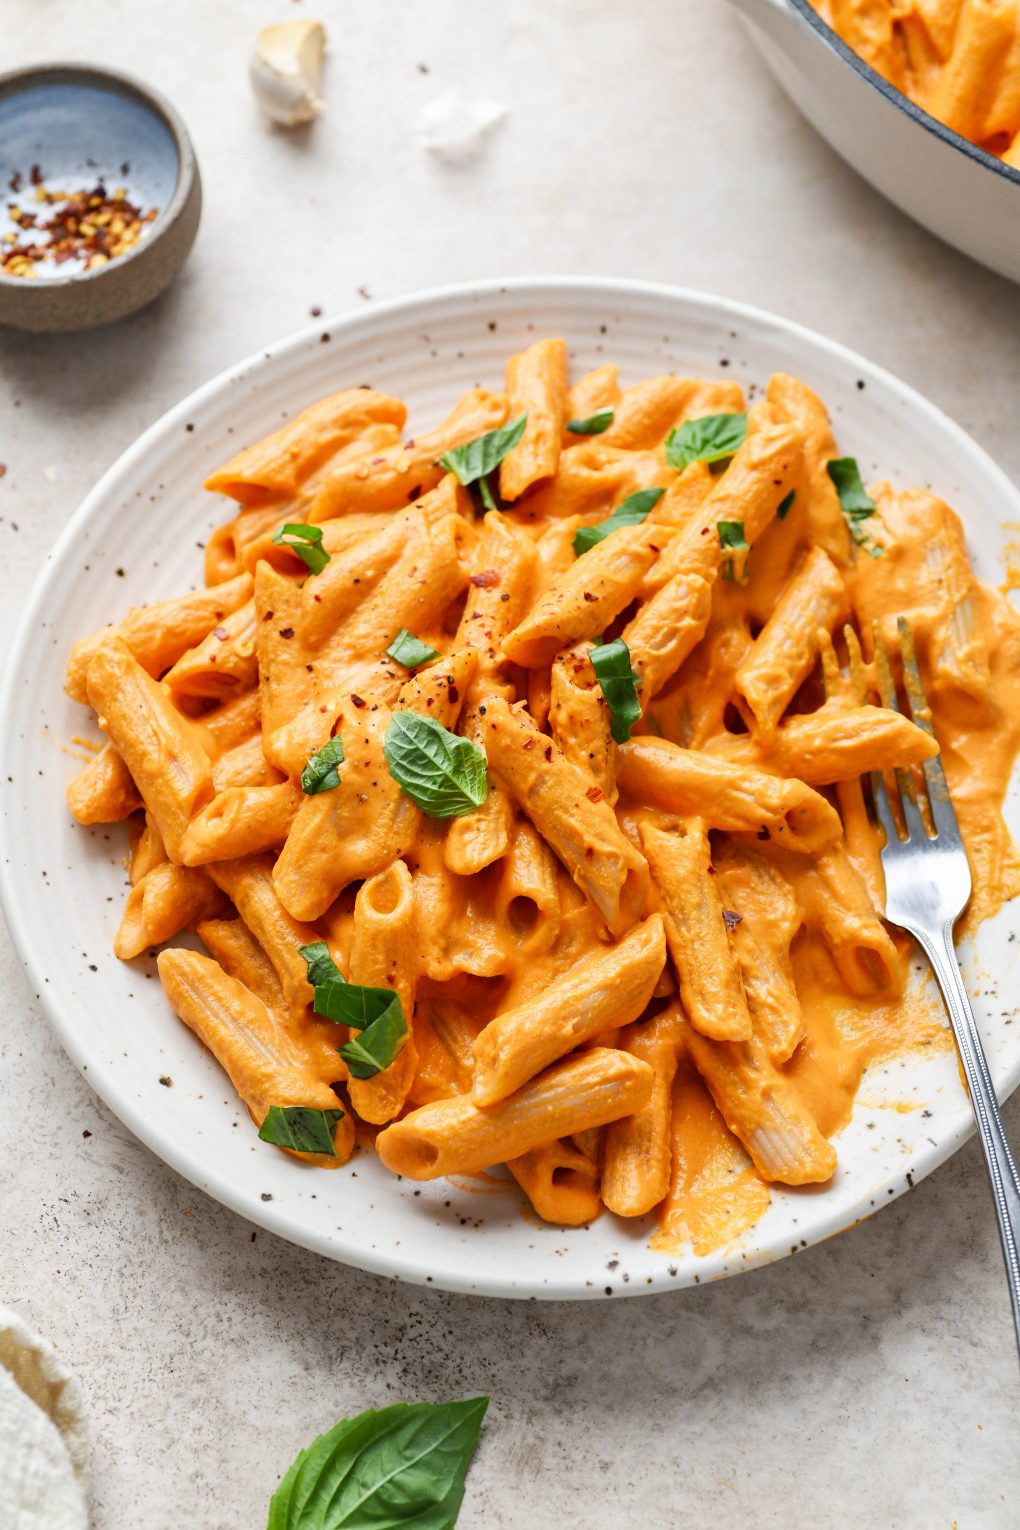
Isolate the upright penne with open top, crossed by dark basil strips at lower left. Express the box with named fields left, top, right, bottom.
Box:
left=347, top=860, right=419, bottom=1126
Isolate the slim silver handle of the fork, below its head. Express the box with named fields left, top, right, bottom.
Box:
left=913, top=920, right=1020, bottom=1346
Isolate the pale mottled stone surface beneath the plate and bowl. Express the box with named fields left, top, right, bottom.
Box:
left=0, top=0, right=1020, bottom=1530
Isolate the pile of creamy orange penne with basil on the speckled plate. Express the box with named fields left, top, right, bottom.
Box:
left=67, top=340, right=1020, bottom=1247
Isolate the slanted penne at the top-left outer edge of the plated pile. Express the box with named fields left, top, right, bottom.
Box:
left=205, top=387, right=407, bottom=505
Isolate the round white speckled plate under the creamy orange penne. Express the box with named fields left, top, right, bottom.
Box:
left=0, top=278, right=1020, bottom=1299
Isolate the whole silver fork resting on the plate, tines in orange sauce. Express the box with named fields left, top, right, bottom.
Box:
left=872, top=617, right=1020, bottom=1346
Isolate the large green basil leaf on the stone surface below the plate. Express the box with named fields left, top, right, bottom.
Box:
left=266, top=1397, right=489, bottom=1530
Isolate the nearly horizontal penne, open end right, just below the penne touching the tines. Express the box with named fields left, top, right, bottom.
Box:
left=616, top=736, right=841, bottom=855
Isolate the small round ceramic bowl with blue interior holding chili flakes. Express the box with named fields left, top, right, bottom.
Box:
left=0, top=64, right=202, bottom=332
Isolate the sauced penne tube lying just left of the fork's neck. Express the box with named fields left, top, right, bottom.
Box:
left=768, top=840, right=907, bottom=996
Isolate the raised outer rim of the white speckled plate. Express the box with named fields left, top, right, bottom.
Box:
left=7, top=275, right=1020, bottom=1301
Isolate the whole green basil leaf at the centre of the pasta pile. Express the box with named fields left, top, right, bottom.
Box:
left=382, top=711, right=489, bottom=819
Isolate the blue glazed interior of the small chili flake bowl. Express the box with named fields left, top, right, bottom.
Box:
left=0, top=78, right=179, bottom=274
